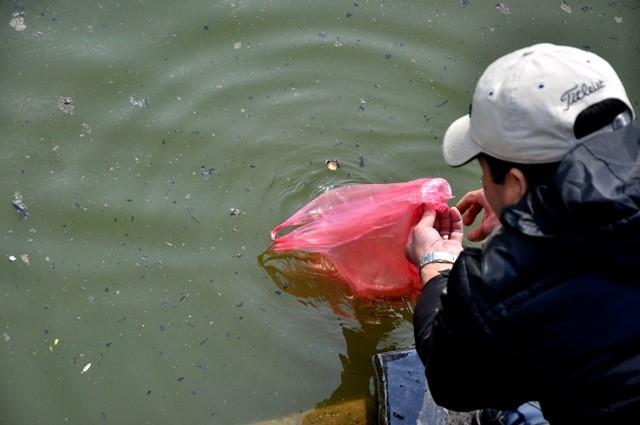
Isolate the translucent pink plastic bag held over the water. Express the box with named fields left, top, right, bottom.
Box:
left=271, top=178, right=452, bottom=300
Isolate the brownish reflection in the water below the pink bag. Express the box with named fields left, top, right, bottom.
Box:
left=258, top=249, right=413, bottom=417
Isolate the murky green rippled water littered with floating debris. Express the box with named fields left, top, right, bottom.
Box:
left=0, top=0, right=640, bottom=424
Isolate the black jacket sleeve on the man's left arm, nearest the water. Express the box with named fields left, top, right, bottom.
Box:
left=414, top=248, right=527, bottom=411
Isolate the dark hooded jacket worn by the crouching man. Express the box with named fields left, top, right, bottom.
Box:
left=414, top=125, right=640, bottom=424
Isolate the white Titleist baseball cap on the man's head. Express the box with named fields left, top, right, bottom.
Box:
left=442, top=43, right=633, bottom=167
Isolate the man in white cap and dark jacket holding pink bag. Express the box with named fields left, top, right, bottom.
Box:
left=406, top=44, right=640, bottom=425
